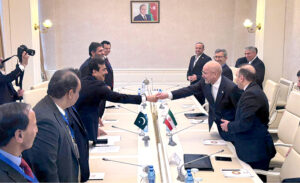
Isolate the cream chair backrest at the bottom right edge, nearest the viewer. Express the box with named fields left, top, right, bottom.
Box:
left=280, top=127, right=300, bottom=181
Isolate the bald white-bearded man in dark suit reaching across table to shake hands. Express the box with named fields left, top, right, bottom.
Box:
left=156, top=61, right=241, bottom=141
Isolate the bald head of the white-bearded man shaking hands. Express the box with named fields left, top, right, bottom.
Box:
left=202, top=61, right=222, bottom=84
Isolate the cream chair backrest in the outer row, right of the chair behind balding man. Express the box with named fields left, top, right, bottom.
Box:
left=277, top=78, right=294, bottom=107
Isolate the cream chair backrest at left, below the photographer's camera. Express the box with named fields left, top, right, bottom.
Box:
left=23, top=88, right=47, bottom=107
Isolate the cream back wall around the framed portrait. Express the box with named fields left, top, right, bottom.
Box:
left=39, top=0, right=256, bottom=69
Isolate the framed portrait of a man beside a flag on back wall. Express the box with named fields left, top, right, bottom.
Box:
left=130, top=1, right=159, bottom=23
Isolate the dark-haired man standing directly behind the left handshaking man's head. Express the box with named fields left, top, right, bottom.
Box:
left=79, top=42, right=104, bottom=77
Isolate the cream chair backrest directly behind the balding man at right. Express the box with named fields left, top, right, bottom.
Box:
left=264, top=79, right=279, bottom=115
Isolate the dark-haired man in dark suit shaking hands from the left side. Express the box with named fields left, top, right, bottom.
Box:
left=76, top=58, right=157, bottom=145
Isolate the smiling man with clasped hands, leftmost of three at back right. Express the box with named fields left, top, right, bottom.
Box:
left=187, top=42, right=211, bottom=105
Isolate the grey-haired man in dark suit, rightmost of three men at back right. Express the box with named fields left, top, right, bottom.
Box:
left=235, top=46, right=265, bottom=88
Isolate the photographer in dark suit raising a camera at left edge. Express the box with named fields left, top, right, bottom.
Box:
left=0, top=51, right=29, bottom=105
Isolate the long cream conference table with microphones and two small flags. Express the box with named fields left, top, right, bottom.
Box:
left=89, top=84, right=261, bottom=183
